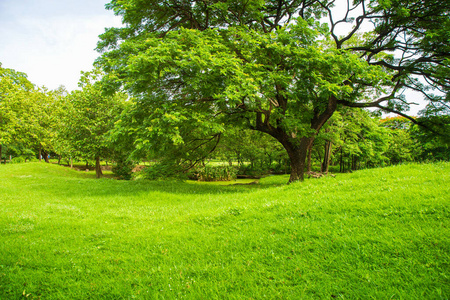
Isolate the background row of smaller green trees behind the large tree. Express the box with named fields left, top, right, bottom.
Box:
left=0, top=62, right=450, bottom=180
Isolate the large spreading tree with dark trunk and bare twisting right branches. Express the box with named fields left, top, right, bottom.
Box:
left=98, top=0, right=450, bottom=182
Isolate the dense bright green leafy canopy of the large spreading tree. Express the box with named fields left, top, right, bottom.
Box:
left=94, top=1, right=404, bottom=179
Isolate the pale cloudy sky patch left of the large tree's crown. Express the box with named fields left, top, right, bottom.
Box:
left=0, top=0, right=121, bottom=91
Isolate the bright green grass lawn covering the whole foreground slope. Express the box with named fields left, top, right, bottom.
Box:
left=0, top=163, right=450, bottom=299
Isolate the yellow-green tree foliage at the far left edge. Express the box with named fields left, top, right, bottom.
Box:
left=0, top=64, right=65, bottom=162
